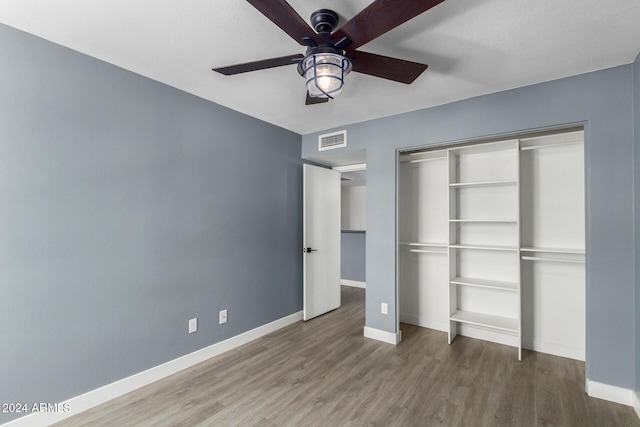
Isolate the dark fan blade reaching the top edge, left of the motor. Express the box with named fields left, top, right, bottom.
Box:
left=247, top=0, right=322, bottom=46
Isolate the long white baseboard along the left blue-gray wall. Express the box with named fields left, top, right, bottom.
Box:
left=2, top=311, right=302, bottom=427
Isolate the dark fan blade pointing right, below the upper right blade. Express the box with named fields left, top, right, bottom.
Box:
left=347, top=50, right=428, bottom=84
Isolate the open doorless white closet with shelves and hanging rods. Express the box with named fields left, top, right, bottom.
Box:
left=398, top=129, right=585, bottom=360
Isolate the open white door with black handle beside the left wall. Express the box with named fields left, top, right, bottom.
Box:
left=302, top=165, right=340, bottom=320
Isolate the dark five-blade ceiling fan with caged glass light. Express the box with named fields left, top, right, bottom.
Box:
left=213, top=0, right=444, bottom=105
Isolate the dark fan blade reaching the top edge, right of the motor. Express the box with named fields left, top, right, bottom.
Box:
left=331, top=0, right=444, bottom=50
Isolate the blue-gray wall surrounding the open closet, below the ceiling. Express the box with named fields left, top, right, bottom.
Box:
left=302, top=65, right=636, bottom=389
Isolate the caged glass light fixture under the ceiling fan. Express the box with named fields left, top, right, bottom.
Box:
left=299, top=52, right=351, bottom=99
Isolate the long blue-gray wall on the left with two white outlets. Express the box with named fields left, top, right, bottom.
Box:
left=0, top=25, right=302, bottom=423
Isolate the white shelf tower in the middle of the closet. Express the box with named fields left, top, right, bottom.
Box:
left=448, top=140, right=521, bottom=358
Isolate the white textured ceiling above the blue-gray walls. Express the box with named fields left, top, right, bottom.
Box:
left=0, top=0, right=640, bottom=134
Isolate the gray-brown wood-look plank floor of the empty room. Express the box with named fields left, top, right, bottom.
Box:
left=57, top=288, right=640, bottom=426
